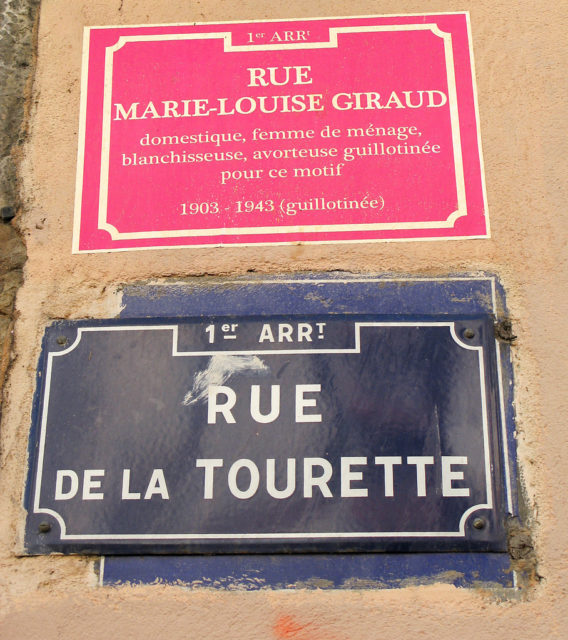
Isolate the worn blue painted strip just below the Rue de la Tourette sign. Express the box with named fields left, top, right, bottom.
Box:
left=102, top=553, right=513, bottom=591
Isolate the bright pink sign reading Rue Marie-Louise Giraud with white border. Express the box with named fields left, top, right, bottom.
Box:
left=73, top=13, right=489, bottom=252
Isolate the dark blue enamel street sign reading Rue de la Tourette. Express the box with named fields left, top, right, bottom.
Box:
left=26, top=314, right=506, bottom=554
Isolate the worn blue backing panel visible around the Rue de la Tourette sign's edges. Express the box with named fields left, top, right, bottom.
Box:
left=24, top=274, right=516, bottom=588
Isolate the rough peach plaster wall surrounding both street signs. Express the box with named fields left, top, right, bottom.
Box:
left=0, top=0, right=568, bottom=640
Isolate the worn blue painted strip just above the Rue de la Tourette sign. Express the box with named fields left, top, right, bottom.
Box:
left=121, top=274, right=501, bottom=318
